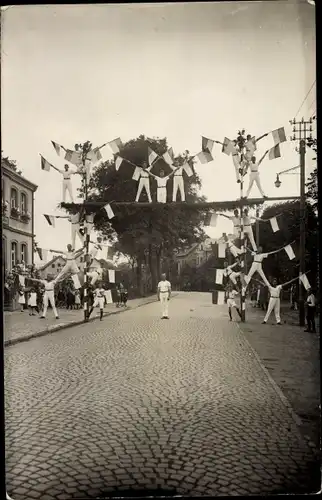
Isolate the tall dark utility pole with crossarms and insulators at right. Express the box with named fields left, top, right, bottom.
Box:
left=290, top=118, right=312, bottom=326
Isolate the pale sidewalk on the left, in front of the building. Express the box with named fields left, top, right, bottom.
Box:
left=3, top=295, right=157, bottom=346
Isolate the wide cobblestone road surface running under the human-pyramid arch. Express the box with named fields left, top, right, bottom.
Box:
left=5, top=293, right=320, bottom=500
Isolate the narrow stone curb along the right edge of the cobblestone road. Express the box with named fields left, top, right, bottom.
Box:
left=235, top=323, right=320, bottom=458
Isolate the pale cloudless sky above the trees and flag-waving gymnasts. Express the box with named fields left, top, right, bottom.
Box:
left=1, top=0, right=316, bottom=264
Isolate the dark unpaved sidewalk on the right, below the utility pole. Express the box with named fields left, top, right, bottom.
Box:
left=238, top=305, right=320, bottom=450
